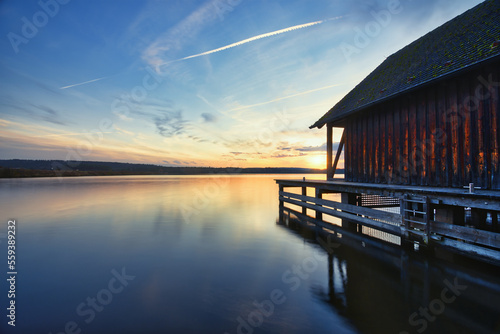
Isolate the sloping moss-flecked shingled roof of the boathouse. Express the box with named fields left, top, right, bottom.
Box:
left=310, top=0, right=500, bottom=129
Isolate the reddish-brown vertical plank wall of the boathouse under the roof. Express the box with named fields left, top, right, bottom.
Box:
left=344, top=60, right=500, bottom=189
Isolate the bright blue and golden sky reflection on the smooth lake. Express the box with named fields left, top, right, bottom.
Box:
left=0, top=175, right=353, bottom=334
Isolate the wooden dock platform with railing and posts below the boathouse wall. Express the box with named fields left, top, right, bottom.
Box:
left=276, top=179, right=500, bottom=265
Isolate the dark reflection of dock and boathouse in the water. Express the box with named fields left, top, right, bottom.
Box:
left=279, top=214, right=500, bottom=333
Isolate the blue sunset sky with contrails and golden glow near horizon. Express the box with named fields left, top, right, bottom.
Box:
left=0, top=0, right=481, bottom=167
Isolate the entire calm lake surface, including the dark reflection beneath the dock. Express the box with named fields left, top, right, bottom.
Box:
left=0, top=175, right=500, bottom=334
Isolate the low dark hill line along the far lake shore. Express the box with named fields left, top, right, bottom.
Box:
left=0, top=159, right=343, bottom=178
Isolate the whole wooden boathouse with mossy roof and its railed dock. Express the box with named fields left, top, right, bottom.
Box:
left=276, top=0, right=500, bottom=265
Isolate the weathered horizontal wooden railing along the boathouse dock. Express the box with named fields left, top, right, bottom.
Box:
left=276, top=180, right=500, bottom=265
